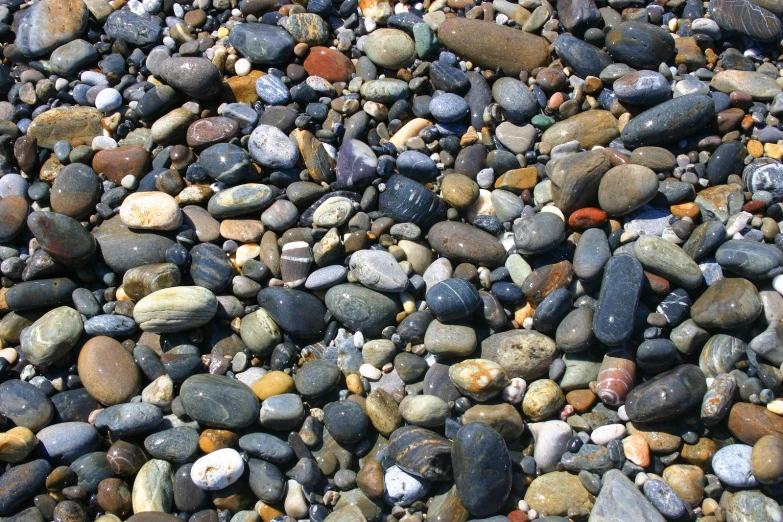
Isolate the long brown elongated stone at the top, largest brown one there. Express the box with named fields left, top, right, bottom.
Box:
left=438, top=17, right=549, bottom=77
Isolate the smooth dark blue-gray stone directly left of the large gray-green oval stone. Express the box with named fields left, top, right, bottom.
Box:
left=258, top=287, right=326, bottom=339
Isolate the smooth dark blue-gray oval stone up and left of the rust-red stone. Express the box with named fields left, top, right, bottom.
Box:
left=228, top=23, right=296, bottom=65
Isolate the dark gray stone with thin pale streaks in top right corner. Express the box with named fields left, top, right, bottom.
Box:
left=710, top=0, right=783, bottom=42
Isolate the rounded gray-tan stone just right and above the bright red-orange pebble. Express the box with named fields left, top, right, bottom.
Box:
left=598, top=164, right=658, bottom=216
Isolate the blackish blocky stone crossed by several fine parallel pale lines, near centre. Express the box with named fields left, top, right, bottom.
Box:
left=378, top=174, right=447, bottom=230
